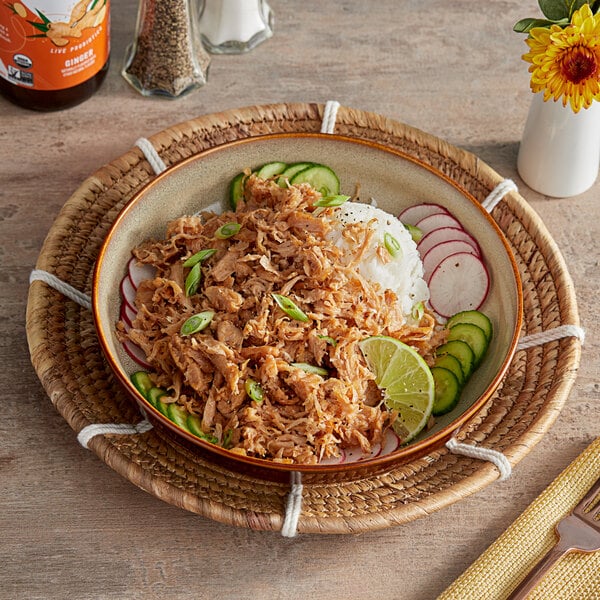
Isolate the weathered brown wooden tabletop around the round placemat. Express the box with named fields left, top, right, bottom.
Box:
left=0, top=0, right=600, bottom=600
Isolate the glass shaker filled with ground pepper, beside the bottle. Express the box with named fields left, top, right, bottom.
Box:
left=121, top=0, right=210, bottom=98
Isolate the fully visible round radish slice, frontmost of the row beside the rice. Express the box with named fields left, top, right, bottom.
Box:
left=429, top=252, right=490, bottom=317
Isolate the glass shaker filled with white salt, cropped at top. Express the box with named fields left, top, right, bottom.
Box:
left=199, top=0, right=273, bottom=54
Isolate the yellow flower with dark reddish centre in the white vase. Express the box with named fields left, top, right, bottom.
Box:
left=523, top=4, right=600, bottom=112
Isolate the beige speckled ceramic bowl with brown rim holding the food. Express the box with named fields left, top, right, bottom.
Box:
left=92, top=133, right=523, bottom=481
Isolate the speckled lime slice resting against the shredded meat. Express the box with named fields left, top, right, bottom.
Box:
left=359, top=335, right=435, bottom=443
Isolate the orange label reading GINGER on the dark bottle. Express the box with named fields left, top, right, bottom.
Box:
left=0, top=0, right=110, bottom=90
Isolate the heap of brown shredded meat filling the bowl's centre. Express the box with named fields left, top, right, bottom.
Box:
left=118, top=176, right=436, bottom=463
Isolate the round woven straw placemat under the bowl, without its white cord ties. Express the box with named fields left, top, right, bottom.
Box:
left=27, top=103, right=580, bottom=533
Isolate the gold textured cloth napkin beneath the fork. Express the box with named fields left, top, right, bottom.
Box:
left=438, top=438, right=600, bottom=600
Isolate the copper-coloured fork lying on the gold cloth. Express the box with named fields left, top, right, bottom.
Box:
left=507, top=478, right=600, bottom=600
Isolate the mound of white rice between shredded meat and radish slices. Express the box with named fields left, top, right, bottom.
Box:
left=323, top=202, right=429, bottom=319
